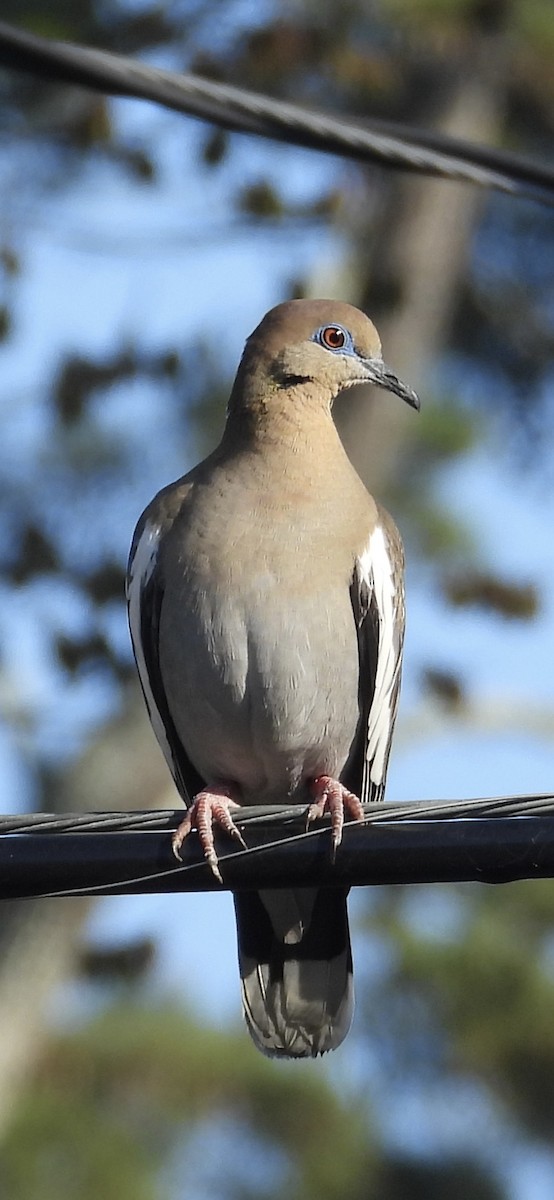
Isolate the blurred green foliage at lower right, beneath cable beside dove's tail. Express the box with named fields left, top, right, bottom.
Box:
left=365, top=880, right=554, bottom=1144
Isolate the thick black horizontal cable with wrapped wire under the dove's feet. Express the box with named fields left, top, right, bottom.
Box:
left=0, top=794, right=554, bottom=899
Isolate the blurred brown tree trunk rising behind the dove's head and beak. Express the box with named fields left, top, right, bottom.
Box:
left=336, top=68, right=502, bottom=493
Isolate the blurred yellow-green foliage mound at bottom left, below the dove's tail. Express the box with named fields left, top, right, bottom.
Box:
left=0, top=998, right=377, bottom=1200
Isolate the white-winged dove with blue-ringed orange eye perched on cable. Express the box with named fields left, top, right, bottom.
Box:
left=127, top=300, right=418, bottom=1057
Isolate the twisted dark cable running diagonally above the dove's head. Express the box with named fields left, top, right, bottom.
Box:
left=0, top=22, right=554, bottom=204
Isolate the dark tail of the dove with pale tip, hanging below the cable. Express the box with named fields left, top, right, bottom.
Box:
left=235, top=888, right=354, bottom=1058
